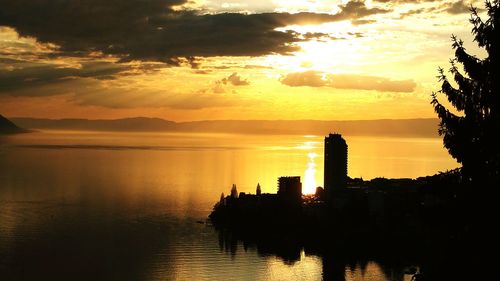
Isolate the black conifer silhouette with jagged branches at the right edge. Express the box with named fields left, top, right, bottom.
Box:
left=431, top=0, right=500, bottom=183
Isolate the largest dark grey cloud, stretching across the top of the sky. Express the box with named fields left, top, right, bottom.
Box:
left=0, top=0, right=389, bottom=67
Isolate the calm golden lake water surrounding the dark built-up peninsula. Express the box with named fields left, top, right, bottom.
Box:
left=0, top=131, right=457, bottom=280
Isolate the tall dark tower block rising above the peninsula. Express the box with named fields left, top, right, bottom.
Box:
left=323, top=134, right=347, bottom=201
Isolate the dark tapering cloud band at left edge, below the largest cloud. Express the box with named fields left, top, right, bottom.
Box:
left=0, top=59, right=128, bottom=95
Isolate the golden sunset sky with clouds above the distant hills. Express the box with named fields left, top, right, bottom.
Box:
left=0, top=0, right=484, bottom=121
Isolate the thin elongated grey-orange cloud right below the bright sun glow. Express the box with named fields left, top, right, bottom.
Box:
left=281, top=71, right=416, bottom=93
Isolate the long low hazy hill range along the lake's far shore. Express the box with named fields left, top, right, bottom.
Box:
left=12, top=117, right=439, bottom=137
